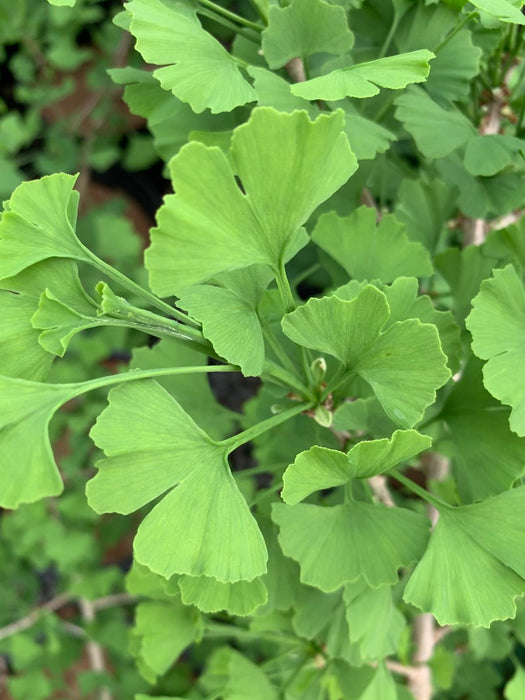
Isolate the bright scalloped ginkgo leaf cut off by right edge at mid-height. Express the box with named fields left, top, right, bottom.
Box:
left=466, top=265, right=525, bottom=437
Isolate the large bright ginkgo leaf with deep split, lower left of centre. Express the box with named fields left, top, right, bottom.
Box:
left=87, top=380, right=267, bottom=583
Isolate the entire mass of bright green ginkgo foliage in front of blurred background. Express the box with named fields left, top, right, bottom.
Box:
left=0, top=0, right=525, bottom=700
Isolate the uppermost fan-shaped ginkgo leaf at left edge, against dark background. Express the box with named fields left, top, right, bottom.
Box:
left=0, top=173, right=91, bottom=279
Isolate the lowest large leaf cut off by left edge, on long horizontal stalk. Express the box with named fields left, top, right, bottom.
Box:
left=0, top=376, right=78, bottom=508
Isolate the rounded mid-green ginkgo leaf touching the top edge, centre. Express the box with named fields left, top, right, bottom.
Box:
left=262, top=0, right=354, bottom=68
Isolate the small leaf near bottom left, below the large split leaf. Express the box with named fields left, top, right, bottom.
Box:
left=132, top=599, right=200, bottom=676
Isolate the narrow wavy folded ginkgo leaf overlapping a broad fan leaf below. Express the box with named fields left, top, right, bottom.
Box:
left=282, top=430, right=432, bottom=505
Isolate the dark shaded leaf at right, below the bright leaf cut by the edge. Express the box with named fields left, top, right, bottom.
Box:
left=439, top=358, right=525, bottom=503
